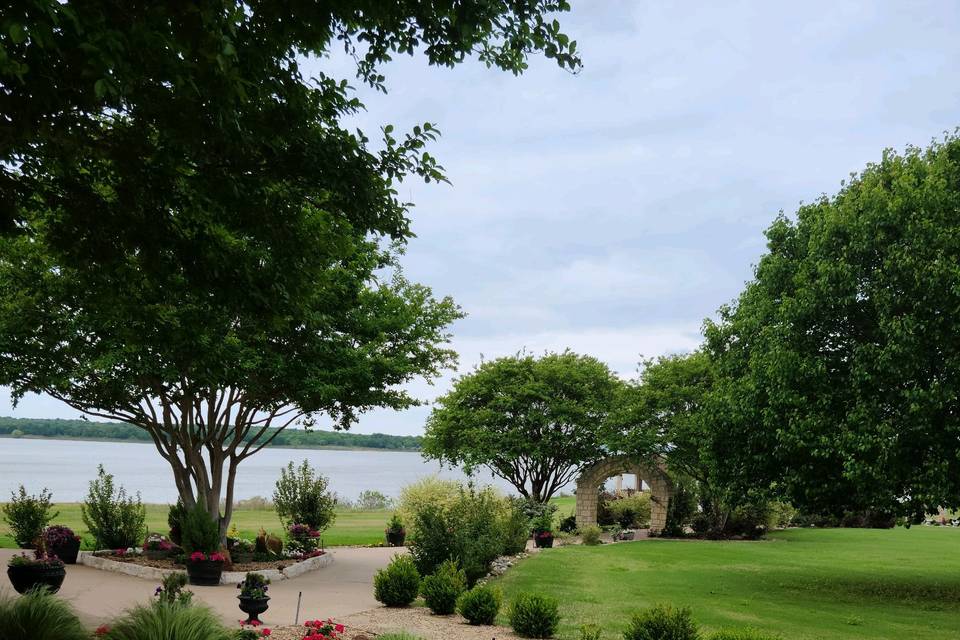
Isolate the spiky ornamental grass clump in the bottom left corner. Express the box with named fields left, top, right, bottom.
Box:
left=0, top=589, right=90, bottom=640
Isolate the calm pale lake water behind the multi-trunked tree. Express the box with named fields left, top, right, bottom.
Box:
left=0, top=438, right=516, bottom=503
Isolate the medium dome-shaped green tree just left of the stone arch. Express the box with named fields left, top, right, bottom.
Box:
left=423, top=351, right=622, bottom=502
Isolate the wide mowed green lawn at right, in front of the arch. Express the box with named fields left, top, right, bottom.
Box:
left=496, top=527, right=960, bottom=640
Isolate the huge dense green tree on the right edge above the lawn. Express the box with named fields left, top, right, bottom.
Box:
left=706, top=135, right=960, bottom=517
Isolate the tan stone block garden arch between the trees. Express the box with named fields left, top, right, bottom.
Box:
left=577, top=456, right=673, bottom=533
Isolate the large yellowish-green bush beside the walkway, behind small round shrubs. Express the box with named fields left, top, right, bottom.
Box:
left=410, top=486, right=504, bottom=586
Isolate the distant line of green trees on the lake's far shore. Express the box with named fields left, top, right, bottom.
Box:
left=0, top=417, right=421, bottom=451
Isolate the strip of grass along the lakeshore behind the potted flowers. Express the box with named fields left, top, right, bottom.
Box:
left=0, top=503, right=392, bottom=549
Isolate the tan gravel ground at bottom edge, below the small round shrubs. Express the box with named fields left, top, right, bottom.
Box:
left=256, top=607, right=519, bottom=640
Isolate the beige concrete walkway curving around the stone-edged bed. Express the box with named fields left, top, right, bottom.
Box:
left=0, top=547, right=398, bottom=626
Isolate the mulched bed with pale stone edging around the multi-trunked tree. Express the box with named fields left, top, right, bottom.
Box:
left=77, top=551, right=333, bottom=584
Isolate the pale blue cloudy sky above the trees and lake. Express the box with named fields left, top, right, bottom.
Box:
left=0, top=0, right=960, bottom=434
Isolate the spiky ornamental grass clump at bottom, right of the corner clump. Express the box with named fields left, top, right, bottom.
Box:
left=106, top=602, right=234, bottom=640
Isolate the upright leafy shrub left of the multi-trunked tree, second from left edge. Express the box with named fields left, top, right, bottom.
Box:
left=80, top=464, right=147, bottom=549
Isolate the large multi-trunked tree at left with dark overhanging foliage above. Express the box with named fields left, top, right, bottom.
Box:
left=0, top=0, right=579, bottom=532
